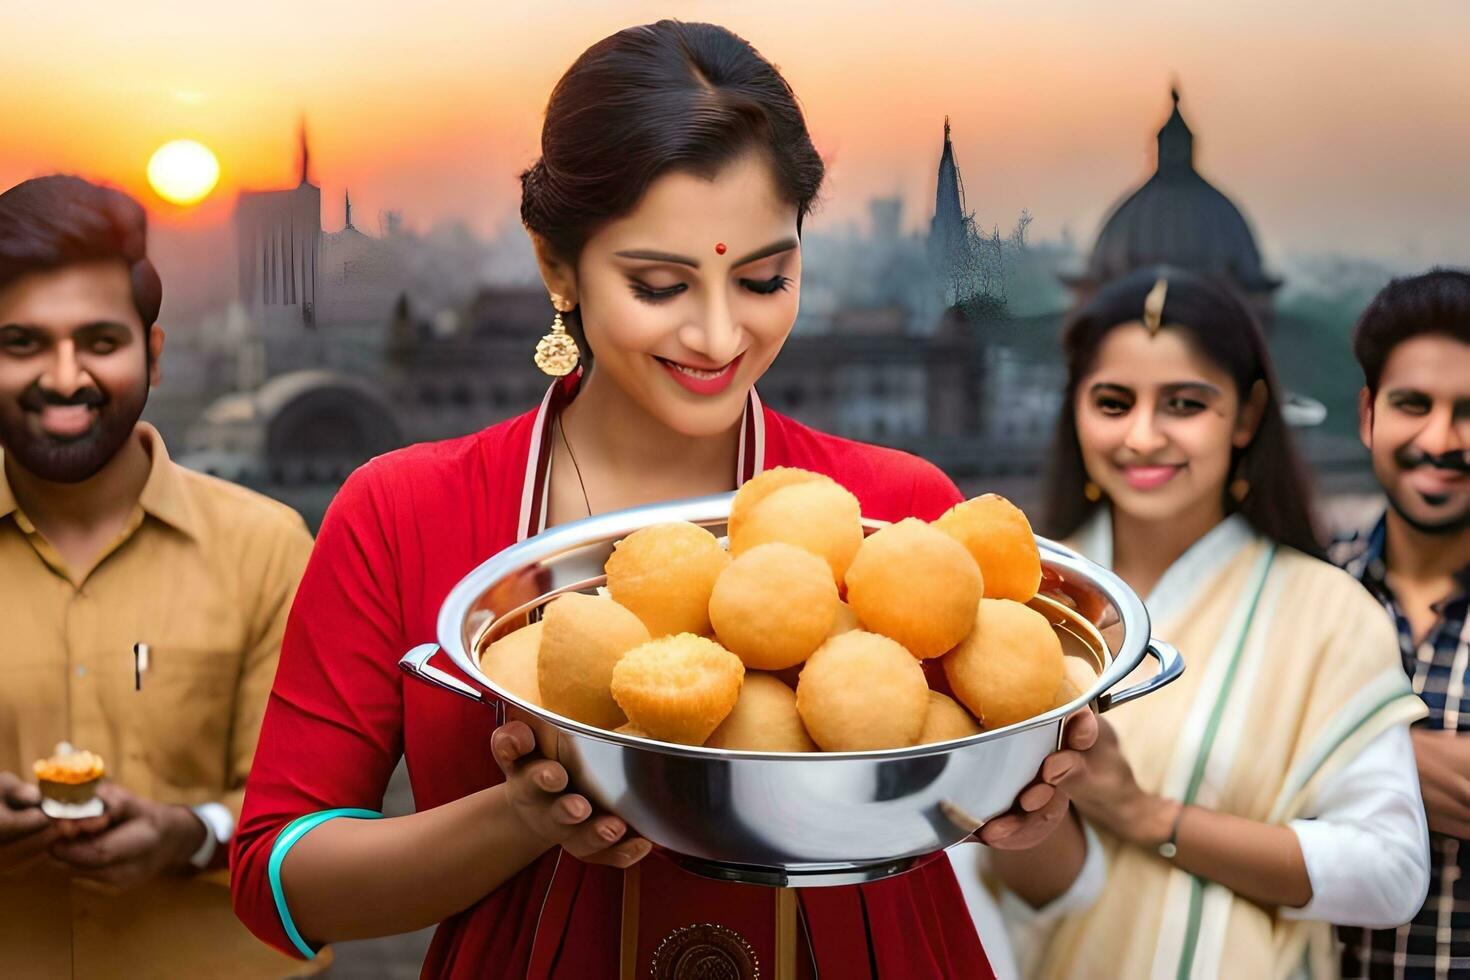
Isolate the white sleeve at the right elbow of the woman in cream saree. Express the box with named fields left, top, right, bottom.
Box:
left=1280, top=724, right=1429, bottom=929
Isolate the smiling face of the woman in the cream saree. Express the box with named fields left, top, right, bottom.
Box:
left=1076, top=323, right=1264, bottom=523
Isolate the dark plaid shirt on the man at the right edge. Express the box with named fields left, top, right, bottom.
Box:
left=1329, top=519, right=1470, bottom=980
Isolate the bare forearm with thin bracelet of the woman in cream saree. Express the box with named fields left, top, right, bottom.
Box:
left=1100, top=796, right=1311, bottom=908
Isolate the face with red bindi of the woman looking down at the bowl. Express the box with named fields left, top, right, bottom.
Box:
left=542, top=151, right=801, bottom=436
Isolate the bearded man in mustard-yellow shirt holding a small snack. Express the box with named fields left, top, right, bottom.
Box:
left=0, top=176, right=315, bottom=977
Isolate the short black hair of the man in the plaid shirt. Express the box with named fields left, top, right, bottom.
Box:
left=1352, top=269, right=1470, bottom=395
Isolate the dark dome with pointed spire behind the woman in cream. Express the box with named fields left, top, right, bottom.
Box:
left=1067, top=90, right=1280, bottom=326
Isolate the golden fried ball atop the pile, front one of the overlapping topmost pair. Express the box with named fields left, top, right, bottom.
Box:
left=731, top=480, right=863, bottom=582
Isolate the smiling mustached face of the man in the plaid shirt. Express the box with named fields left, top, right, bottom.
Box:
left=1360, top=335, right=1470, bottom=533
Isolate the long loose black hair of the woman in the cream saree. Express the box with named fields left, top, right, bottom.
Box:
left=1044, top=266, right=1322, bottom=557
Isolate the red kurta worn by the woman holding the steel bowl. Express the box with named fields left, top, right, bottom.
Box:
left=231, top=382, right=991, bottom=980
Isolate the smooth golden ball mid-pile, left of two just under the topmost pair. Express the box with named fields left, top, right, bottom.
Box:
left=710, top=542, right=839, bottom=670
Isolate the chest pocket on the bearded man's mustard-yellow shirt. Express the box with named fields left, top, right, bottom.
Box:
left=104, top=644, right=240, bottom=802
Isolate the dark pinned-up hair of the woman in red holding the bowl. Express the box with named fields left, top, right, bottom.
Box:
left=520, top=21, right=825, bottom=357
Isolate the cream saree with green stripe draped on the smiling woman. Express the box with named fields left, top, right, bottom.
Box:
left=1036, top=511, right=1424, bottom=980
